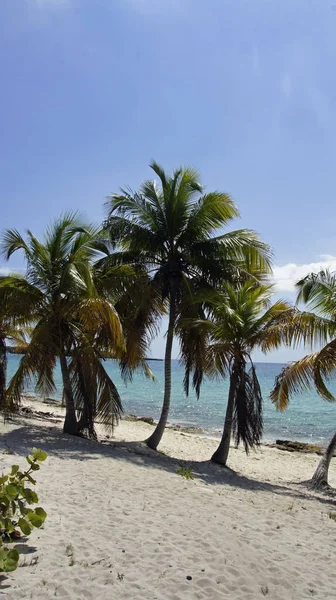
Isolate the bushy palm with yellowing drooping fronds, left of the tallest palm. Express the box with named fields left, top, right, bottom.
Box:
left=0, top=213, right=135, bottom=435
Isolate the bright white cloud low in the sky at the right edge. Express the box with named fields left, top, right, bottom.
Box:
left=273, top=254, right=336, bottom=292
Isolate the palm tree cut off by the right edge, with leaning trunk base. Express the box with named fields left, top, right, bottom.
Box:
left=271, top=271, right=336, bottom=488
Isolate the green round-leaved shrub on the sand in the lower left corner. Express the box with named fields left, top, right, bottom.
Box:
left=0, top=448, right=47, bottom=572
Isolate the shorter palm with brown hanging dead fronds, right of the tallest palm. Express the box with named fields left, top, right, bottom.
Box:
left=194, top=279, right=299, bottom=466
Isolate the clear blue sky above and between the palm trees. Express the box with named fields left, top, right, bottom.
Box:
left=0, top=0, right=336, bottom=360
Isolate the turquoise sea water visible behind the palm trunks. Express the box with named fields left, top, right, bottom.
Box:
left=8, top=355, right=336, bottom=443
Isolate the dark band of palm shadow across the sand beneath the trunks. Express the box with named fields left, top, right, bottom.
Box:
left=0, top=421, right=336, bottom=505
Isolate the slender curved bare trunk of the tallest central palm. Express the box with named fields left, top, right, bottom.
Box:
left=146, top=292, right=176, bottom=450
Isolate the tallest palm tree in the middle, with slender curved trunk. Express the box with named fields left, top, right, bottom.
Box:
left=105, top=162, right=270, bottom=449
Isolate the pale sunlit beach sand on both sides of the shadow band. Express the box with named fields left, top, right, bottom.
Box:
left=0, top=396, right=336, bottom=600
